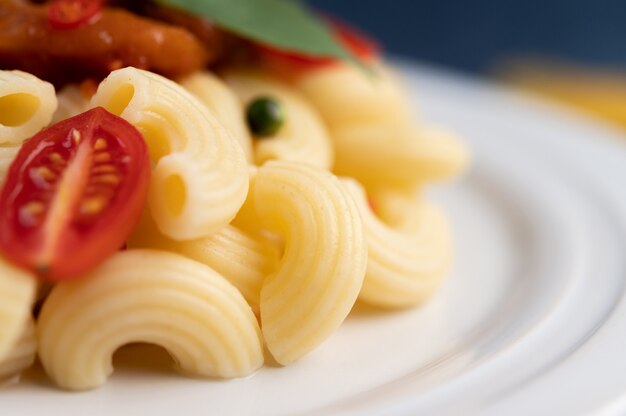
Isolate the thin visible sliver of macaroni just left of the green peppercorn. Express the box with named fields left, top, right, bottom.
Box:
left=178, top=71, right=252, bottom=162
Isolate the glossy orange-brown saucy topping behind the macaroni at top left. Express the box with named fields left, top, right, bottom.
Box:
left=0, top=0, right=220, bottom=85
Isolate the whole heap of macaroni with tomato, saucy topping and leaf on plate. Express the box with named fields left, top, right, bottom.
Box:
left=0, top=0, right=468, bottom=390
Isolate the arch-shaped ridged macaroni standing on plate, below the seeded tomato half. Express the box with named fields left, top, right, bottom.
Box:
left=37, top=250, right=263, bottom=390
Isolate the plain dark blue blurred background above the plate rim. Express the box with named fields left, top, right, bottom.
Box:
left=308, top=0, right=626, bottom=71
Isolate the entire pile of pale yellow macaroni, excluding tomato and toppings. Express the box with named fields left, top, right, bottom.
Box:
left=0, top=55, right=468, bottom=390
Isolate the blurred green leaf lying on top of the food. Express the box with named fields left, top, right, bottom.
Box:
left=157, top=0, right=364, bottom=68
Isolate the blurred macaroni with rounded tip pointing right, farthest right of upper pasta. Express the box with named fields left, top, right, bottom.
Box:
left=333, top=124, right=468, bottom=189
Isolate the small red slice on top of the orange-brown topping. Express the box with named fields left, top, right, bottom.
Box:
left=48, top=0, right=105, bottom=29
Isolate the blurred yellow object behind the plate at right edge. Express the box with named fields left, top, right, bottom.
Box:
left=497, top=60, right=626, bottom=129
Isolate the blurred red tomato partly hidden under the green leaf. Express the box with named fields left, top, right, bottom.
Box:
left=259, top=18, right=380, bottom=72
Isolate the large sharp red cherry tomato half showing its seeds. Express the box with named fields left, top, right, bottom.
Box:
left=0, top=107, right=150, bottom=281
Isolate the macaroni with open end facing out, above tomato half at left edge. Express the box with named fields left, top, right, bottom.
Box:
left=0, top=71, right=57, bottom=146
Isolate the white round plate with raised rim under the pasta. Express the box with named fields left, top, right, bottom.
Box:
left=0, top=64, right=626, bottom=416
